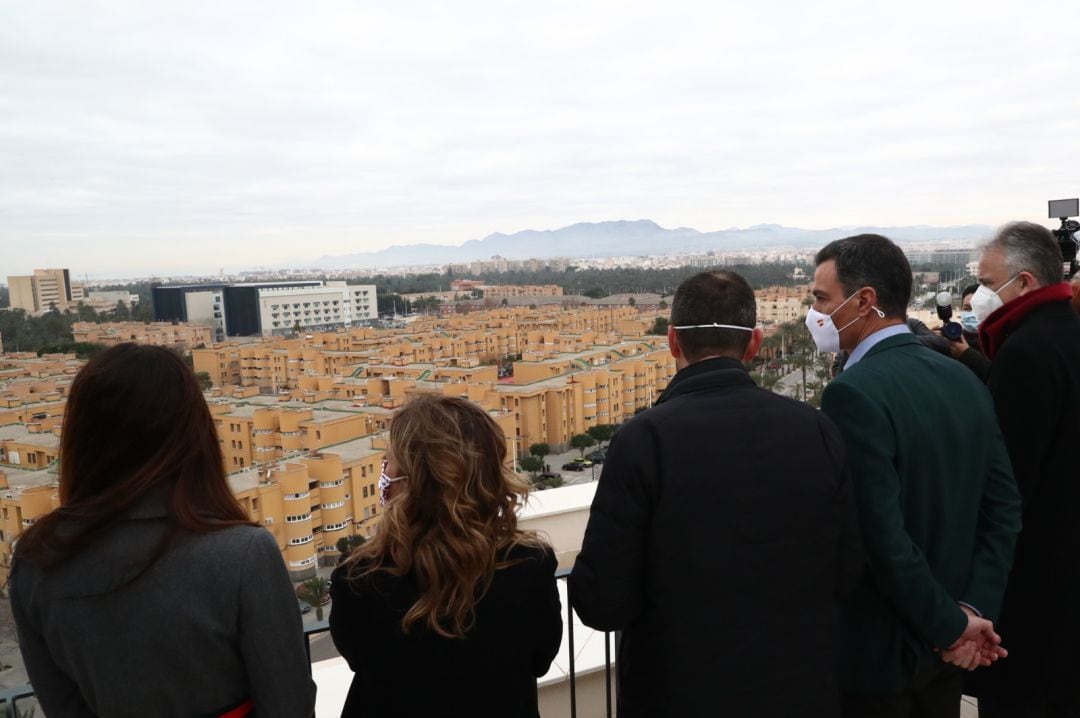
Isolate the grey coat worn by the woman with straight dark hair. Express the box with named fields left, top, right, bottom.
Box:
left=11, top=499, right=315, bottom=718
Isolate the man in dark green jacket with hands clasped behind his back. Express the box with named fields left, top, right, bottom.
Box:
left=807, top=234, right=1021, bottom=718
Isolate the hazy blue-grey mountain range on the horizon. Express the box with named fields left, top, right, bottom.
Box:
left=308, top=219, right=993, bottom=269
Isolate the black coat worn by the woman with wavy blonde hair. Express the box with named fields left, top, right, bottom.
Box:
left=329, top=546, right=563, bottom=718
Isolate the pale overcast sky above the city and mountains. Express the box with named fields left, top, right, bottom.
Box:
left=0, top=0, right=1080, bottom=281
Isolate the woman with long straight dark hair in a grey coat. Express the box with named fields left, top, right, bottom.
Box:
left=11, top=344, right=314, bottom=718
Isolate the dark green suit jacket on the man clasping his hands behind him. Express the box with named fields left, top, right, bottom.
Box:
left=822, top=335, right=1021, bottom=695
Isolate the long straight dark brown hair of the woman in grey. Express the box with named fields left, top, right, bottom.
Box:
left=16, top=343, right=252, bottom=570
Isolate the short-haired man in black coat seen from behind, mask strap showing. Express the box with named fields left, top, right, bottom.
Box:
left=570, top=272, right=862, bottom=718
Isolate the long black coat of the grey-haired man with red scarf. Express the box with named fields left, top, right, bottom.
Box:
left=972, top=301, right=1080, bottom=697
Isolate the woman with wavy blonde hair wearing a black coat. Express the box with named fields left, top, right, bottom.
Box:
left=330, top=395, right=563, bottom=718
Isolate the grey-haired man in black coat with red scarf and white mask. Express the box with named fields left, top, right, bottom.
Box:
left=970, top=222, right=1080, bottom=718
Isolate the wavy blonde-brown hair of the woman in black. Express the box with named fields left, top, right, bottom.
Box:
left=345, top=394, right=546, bottom=638
